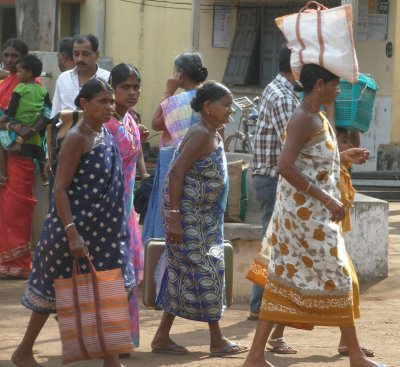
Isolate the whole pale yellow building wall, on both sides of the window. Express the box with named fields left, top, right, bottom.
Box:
left=71, top=0, right=400, bottom=152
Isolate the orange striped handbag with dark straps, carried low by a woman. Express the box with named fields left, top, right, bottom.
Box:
left=55, top=258, right=133, bottom=364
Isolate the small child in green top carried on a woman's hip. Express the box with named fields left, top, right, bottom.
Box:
left=0, top=55, right=51, bottom=185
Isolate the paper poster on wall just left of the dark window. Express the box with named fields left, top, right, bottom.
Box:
left=212, top=3, right=232, bottom=48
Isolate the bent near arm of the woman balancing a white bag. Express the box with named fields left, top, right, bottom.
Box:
left=278, top=111, right=345, bottom=221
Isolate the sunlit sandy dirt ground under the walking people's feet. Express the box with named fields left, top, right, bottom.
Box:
left=0, top=203, right=400, bottom=367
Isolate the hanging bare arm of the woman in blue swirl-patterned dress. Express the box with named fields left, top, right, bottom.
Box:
left=167, top=125, right=214, bottom=244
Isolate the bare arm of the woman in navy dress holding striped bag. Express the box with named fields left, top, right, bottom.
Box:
left=54, top=128, right=88, bottom=258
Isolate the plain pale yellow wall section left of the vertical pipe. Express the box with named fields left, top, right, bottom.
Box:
left=81, top=0, right=191, bottom=145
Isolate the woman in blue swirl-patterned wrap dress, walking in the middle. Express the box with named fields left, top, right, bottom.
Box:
left=151, top=82, right=246, bottom=356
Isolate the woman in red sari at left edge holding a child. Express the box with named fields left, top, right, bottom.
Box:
left=0, top=38, right=46, bottom=278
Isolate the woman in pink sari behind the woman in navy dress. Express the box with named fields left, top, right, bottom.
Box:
left=105, top=64, right=143, bottom=347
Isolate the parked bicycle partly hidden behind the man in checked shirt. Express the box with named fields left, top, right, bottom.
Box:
left=224, top=96, right=259, bottom=154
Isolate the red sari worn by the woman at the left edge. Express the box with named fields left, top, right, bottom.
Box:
left=0, top=74, right=36, bottom=278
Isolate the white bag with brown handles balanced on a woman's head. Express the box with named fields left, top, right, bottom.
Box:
left=275, top=1, right=358, bottom=84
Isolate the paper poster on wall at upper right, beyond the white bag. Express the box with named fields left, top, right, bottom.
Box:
left=357, top=0, right=389, bottom=41
